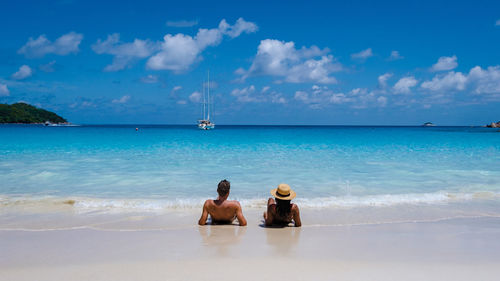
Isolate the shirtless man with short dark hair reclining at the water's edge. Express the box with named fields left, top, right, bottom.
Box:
left=198, top=180, right=247, bottom=226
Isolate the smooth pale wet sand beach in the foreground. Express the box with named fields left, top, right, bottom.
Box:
left=0, top=210, right=500, bottom=281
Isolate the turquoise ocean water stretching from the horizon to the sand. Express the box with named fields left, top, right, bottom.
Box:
left=0, top=125, right=500, bottom=211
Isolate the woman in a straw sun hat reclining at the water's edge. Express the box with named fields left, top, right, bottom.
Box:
left=264, top=183, right=302, bottom=227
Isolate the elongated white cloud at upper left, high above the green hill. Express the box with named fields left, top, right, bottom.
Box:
left=17, top=32, right=83, bottom=58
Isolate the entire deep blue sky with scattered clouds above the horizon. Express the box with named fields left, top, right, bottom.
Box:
left=0, top=0, right=500, bottom=125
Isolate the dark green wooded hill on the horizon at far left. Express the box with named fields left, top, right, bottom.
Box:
left=0, top=102, right=67, bottom=123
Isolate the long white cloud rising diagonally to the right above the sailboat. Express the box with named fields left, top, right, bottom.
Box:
left=147, top=18, right=257, bottom=72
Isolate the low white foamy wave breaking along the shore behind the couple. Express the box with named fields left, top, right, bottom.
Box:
left=0, top=192, right=500, bottom=212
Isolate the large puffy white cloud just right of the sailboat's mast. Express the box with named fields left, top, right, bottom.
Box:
left=241, top=39, right=341, bottom=84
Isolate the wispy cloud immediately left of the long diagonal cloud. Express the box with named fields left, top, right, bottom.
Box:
left=92, top=33, right=158, bottom=71
